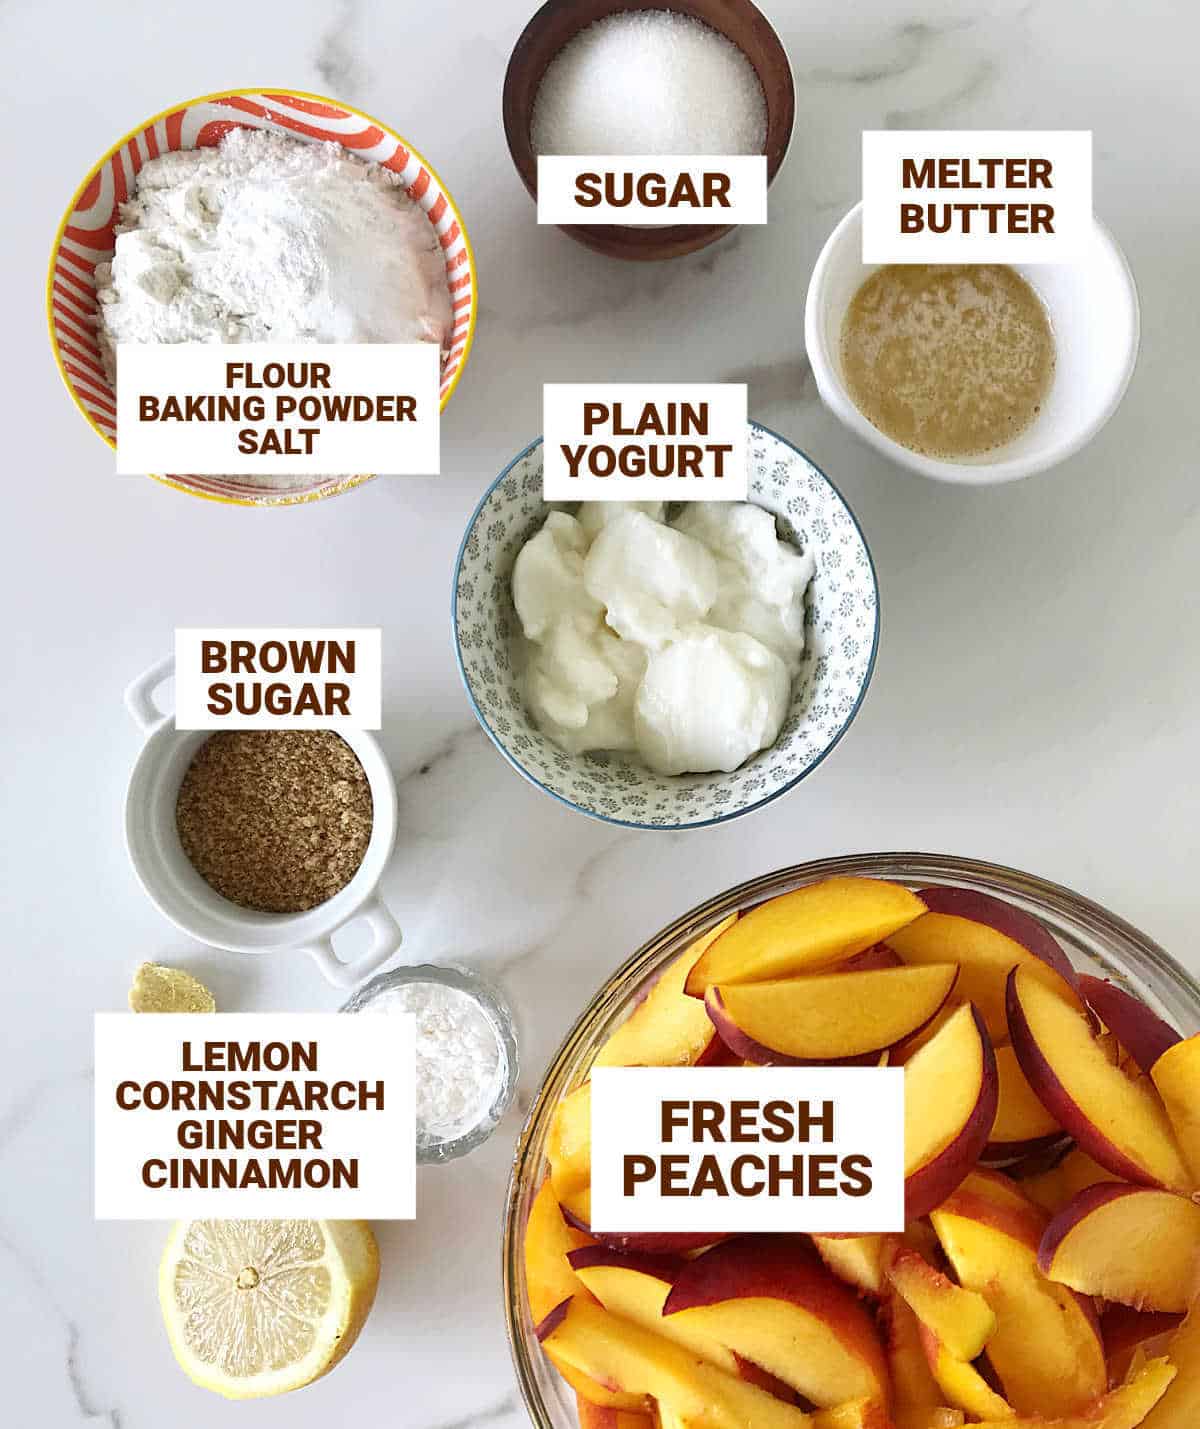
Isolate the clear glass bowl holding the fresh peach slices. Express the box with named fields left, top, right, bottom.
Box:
left=504, top=853, right=1200, bottom=1429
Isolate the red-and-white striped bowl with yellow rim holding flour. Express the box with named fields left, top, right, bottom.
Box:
left=46, top=89, right=479, bottom=506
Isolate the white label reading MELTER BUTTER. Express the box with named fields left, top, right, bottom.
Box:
left=863, top=129, right=1093, bottom=263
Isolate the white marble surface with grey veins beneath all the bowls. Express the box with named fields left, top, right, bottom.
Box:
left=0, top=0, right=1200, bottom=1429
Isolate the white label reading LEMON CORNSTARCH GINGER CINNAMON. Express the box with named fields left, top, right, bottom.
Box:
left=96, top=1013, right=416, bottom=1220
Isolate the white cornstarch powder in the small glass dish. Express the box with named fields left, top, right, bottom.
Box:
left=363, top=982, right=507, bottom=1142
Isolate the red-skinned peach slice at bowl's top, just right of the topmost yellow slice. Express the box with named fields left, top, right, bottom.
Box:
left=887, top=889, right=1074, bottom=1043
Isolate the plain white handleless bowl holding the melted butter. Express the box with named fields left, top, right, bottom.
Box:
left=804, top=204, right=1140, bottom=486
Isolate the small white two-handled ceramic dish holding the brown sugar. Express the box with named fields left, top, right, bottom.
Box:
left=126, top=660, right=400, bottom=987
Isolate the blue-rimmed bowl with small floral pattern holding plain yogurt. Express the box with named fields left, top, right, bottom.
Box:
left=451, top=423, right=879, bottom=829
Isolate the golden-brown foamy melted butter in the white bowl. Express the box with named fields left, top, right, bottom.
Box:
left=841, top=264, right=1054, bottom=459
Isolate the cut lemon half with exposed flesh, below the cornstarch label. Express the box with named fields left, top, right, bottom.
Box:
left=159, top=1220, right=379, bottom=1399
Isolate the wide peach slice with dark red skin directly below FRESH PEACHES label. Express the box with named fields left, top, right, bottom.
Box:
left=663, top=1235, right=887, bottom=1406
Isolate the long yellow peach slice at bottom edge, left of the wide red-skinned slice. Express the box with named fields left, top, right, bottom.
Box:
left=537, top=1296, right=811, bottom=1429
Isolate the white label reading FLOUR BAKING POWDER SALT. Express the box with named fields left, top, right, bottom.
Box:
left=117, top=343, right=441, bottom=476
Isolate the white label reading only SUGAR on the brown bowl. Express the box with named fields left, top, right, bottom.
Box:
left=537, top=154, right=767, bottom=227
